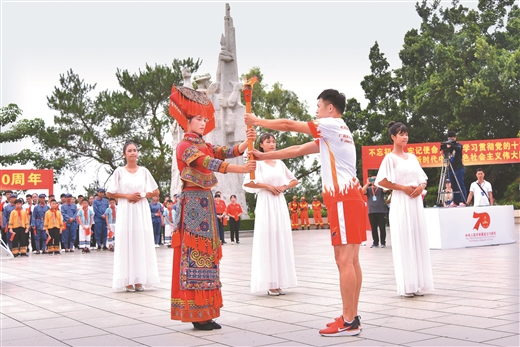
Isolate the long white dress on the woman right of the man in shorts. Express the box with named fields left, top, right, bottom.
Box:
left=375, top=153, right=433, bottom=295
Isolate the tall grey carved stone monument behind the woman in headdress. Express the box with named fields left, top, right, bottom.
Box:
left=171, top=4, right=250, bottom=219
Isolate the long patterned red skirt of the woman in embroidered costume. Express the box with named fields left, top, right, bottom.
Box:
left=171, top=188, right=222, bottom=322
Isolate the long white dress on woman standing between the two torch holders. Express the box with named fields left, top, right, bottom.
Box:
left=244, top=160, right=298, bottom=293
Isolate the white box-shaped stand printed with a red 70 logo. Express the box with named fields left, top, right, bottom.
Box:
left=424, top=205, right=516, bottom=249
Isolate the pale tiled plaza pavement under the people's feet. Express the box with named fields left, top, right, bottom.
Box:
left=0, top=225, right=519, bottom=346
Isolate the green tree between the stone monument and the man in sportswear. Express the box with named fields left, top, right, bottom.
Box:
left=242, top=67, right=321, bottom=212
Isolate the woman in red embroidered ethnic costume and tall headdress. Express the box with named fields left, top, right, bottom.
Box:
left=170, top=86, right=256, bottom=330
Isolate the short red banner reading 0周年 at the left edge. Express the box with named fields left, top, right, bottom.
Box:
left=0, top=169, right=54, bottom=194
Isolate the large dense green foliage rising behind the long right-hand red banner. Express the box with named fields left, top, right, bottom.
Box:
left=346, top=0, right=520, bottom=203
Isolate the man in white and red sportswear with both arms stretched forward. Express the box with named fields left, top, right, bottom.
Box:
left=244, top=89, right=367, bottom=336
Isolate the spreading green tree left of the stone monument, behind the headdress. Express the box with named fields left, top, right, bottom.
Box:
left=38, top=58, right=202, bottom=191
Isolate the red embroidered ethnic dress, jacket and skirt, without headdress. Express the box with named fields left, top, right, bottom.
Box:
left=171, top=133, right=241, bottom=322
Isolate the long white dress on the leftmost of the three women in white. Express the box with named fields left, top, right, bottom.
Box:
left=107, top=166, right=159, bottom=289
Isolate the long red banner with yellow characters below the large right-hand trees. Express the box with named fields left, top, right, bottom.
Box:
left=361, top=138, right=520, bottom=182
